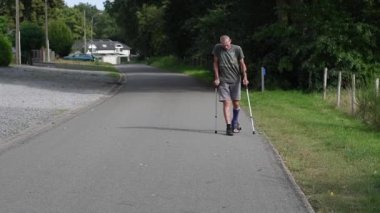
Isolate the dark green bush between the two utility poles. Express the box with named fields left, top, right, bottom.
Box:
left=20, top=21, right=45, bottom=64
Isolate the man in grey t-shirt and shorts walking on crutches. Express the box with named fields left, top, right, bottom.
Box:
left=212, top=35, right=249, bottom=136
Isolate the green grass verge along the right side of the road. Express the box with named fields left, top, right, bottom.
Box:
left=151, top=58, right=380, bottom=212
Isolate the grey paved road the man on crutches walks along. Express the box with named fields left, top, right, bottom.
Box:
left=0, top=65, right=308, bottom=213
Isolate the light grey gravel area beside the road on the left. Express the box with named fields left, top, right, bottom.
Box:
left=0, top=66, right=121, bottom=145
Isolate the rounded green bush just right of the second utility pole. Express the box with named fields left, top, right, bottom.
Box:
left=49, top=20, right=74, bottom=56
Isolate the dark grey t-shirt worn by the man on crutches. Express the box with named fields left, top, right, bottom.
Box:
left=212, top=44, right=244, bottom=83
